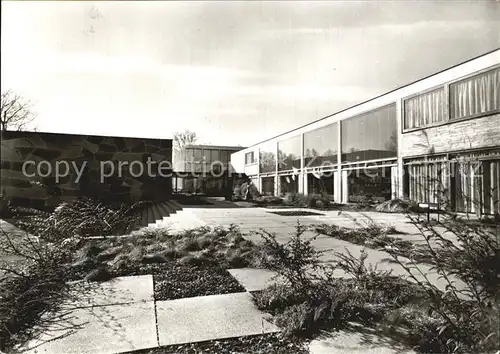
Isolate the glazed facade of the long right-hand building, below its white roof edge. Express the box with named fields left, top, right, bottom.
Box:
left=240, top=65, right=500, bottom=213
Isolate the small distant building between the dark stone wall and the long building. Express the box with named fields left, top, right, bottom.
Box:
left=172, top=145, right=244, bottom=196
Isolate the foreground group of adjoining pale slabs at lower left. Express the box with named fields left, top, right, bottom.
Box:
left=18, top=275, right=279, bottom=354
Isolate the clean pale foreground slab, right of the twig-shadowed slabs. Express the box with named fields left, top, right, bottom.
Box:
left=156, top=292, right=279, bottom=346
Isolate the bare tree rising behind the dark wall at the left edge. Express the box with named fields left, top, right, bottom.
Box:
left=0, top=90, right=36, bottom=131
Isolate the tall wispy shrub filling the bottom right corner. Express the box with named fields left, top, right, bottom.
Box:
left=393, top=216, right=500, bottom=353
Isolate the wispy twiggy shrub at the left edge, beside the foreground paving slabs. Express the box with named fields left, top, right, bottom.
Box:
left=0, top=230, right=75, bottom=351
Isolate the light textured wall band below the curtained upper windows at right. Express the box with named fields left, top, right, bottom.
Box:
left=400, top=114, right=500, bottom=157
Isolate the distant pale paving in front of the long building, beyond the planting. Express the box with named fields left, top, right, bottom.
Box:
left=174, top=208, right=465, bottom=291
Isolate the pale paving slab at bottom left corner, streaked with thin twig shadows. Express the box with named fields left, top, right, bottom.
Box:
left=19, top=301, right=158, bottom=354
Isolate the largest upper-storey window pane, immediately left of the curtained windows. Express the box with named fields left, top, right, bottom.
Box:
left=341, top=104, right=398, bottom=162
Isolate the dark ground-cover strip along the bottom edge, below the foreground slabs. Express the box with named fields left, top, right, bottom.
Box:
left=125, top=333, right=309, bottom=354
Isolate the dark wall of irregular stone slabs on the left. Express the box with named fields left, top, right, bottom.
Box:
left=0, top=131, right=172, bottom=209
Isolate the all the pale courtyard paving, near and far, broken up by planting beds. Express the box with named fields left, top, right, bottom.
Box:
left=3, top=207, right=464, bottom=354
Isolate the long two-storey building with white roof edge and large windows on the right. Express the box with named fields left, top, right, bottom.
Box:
left=231, top=50, right=500, bottom=214
